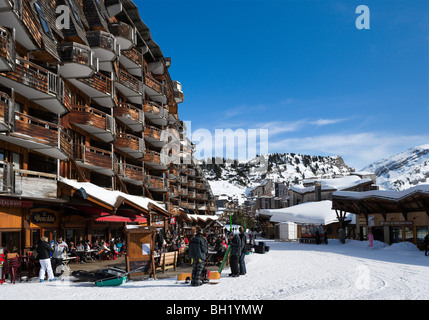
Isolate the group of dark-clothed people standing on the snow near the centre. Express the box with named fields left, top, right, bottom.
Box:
left=188, top=227, right=247, bottom=286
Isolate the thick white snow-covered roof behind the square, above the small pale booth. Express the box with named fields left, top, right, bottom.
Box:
left=260, top=200, right=354, bottom=225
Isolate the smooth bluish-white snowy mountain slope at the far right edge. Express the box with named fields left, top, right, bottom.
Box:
left=362, top=144, right=429, bottom=191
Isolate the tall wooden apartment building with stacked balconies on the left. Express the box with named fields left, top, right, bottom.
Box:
left=0, top=0, right=216, bottom=251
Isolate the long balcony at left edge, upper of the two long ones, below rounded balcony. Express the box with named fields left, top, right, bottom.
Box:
left=0, top=57, right=68, bottom=115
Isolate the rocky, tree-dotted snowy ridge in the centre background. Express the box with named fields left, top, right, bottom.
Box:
left=200, top=153, right=354, bottom=195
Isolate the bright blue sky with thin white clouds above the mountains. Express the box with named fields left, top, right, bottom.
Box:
left=138, top=0, right=429, bottom=169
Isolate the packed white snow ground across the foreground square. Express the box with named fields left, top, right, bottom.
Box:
left=0, top=240, right=429, bottom=301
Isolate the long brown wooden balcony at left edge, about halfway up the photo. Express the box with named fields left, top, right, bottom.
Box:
left=0, top=112, right=71, bottom=160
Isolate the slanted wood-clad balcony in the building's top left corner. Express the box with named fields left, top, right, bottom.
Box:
left=0, top=0, right=42, bottom=51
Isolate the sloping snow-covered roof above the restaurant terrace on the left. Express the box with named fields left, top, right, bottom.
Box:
left=59, top=178, right=167, bottom=212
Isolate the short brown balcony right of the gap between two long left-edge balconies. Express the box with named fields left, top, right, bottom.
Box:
left=66, top=105, right=116, bottom=142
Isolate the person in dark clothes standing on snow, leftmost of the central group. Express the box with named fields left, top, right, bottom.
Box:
left=188, top=229, right=208, bottom=286
